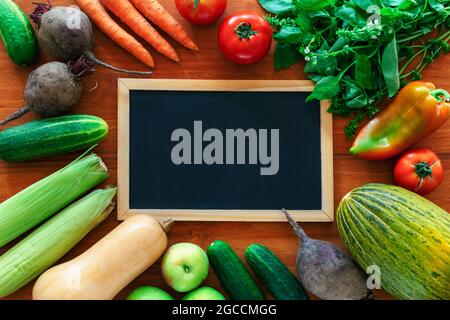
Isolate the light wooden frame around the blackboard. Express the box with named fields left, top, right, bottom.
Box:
left=117, top=79, right=334, bottom=222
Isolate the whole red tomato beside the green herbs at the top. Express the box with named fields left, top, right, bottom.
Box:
left=219, top=13, right=272, bottom=64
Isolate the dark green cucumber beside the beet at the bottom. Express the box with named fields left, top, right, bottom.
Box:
left=245, top=244, right=309, bottom=300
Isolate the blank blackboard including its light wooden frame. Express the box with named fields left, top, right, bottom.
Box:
left=118, top=79, right=333, bottom=221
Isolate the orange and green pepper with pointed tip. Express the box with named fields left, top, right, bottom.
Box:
left=350, top=81, right=450, bottom=160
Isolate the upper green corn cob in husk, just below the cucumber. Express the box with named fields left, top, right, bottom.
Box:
left=0, top=154, right=109, bottom=247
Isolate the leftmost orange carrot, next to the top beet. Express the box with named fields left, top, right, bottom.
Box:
left=76, top=0, right=155, bottom=67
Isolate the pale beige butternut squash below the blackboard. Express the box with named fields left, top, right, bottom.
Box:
left=33, top=215, right=170, bottom=300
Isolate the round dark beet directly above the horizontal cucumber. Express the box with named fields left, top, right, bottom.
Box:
left=0, top=59, right=93, bottom=125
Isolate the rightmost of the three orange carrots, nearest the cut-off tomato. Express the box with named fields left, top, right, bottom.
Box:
left=130, top=0, right=198, bottom=51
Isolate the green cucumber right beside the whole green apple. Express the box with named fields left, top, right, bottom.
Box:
left=208, top=240, right=266, bottom=300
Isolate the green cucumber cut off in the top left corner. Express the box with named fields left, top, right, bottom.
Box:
left=0, top=0, right=39, bottom=67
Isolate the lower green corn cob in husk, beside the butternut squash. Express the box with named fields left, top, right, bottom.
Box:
left=0, top=188, right=117, bottom=298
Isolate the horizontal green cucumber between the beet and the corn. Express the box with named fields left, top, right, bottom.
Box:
left=0, top=115, right=108, bottom=162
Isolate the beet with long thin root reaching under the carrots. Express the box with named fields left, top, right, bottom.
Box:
left=31, top=3, right=152, bottom=75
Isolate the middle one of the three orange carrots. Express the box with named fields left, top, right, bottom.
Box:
left=102, top=0, right=180, bottom=62
